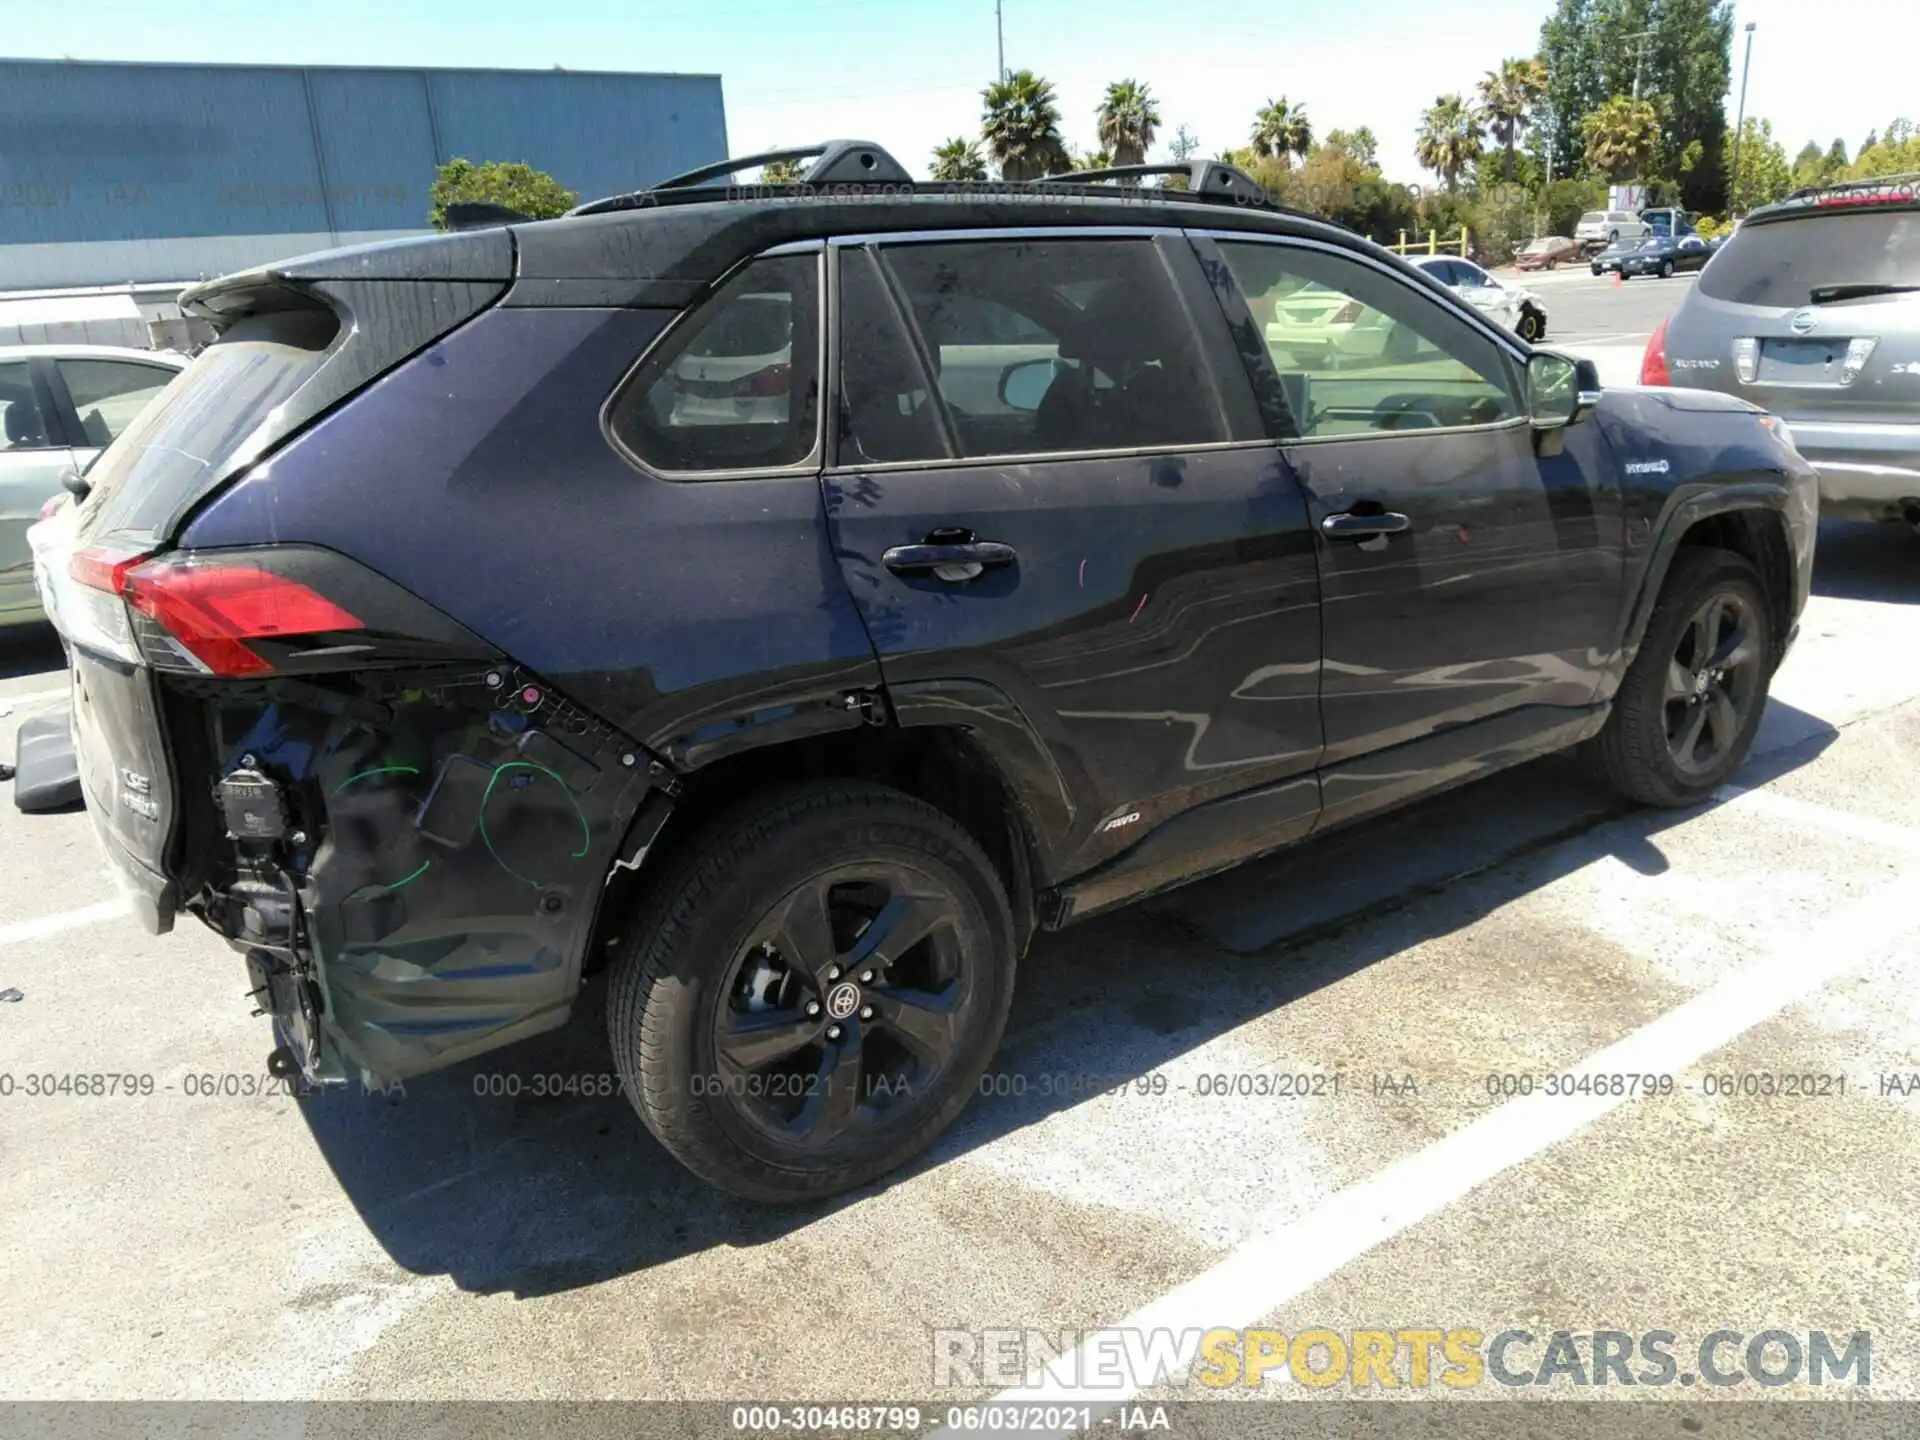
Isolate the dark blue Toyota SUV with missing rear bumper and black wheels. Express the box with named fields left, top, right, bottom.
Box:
left=45, top=142, right=1816, bottom=1198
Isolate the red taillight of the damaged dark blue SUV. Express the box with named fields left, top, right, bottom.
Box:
left=67, top=547, right=363, bottom=680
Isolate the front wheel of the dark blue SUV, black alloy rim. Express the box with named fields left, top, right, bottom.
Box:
left=1594, top=547, right=1774, bottom=806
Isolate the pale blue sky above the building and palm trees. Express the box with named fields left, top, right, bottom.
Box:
left=0, top=0, right=1896, bottom=180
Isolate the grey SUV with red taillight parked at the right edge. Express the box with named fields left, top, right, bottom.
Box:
left=1640, top=175, right=1920, bottom=528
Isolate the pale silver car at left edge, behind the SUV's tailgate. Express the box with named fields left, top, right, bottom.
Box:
left=0, top=346, right=186, bottom=630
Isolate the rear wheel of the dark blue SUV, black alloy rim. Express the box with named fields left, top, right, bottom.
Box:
left=607, top=781, right=1016, bottom=1202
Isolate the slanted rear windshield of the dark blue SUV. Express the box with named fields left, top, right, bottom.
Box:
left=83, top=317, right=332, bottom=536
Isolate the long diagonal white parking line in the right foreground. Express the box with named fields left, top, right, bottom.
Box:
left=967, top=840, right=1920, bottom=1409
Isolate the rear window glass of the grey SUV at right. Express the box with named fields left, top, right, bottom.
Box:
left=1699, top=209, right=1920, bottom=307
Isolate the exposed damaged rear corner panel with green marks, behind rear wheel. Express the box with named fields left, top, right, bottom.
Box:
left=198, top=666, right=649, bottom=1081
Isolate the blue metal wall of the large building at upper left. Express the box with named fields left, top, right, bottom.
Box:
left=0, top=60, right=728, bottom=247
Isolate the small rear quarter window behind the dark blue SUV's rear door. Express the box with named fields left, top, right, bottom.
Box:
left=607, top=252, right=820, bottom=474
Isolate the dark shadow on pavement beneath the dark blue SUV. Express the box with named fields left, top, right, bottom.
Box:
left=301, top=701, right=1836, bottom=1296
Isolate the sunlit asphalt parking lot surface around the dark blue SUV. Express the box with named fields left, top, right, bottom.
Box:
left=0, top=349, right=1920, bottom=1402
